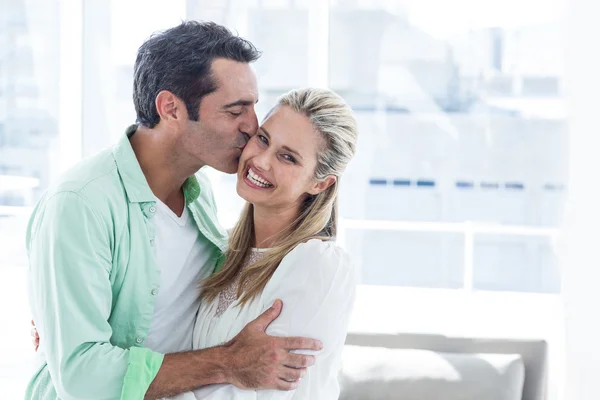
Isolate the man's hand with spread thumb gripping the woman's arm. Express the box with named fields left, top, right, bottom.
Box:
left=225, top=300, right=323, bottom=390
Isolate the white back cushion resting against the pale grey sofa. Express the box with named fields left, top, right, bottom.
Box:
left=340, top=345, right=525, bottom=400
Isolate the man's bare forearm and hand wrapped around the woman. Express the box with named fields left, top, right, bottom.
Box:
left=145, top=300, right=322, bottom=400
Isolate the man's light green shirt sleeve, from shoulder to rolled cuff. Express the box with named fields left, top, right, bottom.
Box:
left=27, top=191, right=164, bottom=400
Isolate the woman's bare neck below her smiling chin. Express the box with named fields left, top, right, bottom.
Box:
left=253, top=205, right=298, bottom=248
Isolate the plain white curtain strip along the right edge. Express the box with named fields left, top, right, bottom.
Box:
left=557, top=0, right=600, bottom=400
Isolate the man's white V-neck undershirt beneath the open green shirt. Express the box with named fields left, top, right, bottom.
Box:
left=145, top=198, right=216, bottom=354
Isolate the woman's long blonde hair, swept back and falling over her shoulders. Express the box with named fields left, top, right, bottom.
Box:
left=202, top=88, right=358, bottom=306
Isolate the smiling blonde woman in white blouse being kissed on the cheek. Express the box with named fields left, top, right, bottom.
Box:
left=178, top=89, right=357, bottom=399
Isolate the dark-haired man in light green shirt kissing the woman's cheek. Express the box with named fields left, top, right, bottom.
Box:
left=26, top=22, right=321, bottom=400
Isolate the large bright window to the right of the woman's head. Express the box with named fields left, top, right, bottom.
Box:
left=329, top=1, right=567, bottom=293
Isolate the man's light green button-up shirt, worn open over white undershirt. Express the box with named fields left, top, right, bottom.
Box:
left=25, top=126, right=227, bottom=400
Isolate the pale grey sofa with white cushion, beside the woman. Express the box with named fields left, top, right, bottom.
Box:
left=340, top=333, right=547, bottom=400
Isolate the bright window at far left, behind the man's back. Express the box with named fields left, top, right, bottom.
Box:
left=0, top=0, right=66, bottom=398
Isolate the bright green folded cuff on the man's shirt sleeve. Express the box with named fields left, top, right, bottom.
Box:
left=121, top=347, right=165, bottom=400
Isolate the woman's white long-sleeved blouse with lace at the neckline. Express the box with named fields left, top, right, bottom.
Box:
left=169, top=239, right=356, bottom=400
